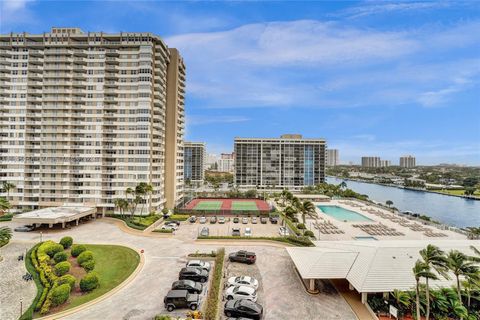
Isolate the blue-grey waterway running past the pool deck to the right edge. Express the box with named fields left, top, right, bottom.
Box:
left=327, top=177, right=480, bottom=227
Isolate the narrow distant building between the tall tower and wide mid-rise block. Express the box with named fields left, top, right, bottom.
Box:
left=183, top=142, right=205, bottom=182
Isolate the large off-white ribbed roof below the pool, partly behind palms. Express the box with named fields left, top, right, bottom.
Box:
left=287, top=240, right=480, bottom=292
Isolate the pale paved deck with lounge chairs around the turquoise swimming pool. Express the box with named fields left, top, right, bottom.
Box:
left=306, top=200, right=466, bottom=241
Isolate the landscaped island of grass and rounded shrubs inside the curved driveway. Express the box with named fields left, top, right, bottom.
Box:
left=21, top=237, right=140, bottom=319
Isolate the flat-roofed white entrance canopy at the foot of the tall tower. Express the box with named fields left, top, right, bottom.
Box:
left=12, top=206, right=96, bottom=228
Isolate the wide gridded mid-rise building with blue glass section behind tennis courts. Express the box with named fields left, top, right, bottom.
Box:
left=235, top=134, right=325, bottom=190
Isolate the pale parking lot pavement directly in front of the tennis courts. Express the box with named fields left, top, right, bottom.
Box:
left=175, top=217, right=281, bottom=239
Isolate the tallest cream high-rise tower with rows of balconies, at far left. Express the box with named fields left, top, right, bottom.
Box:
left=0, top=28, right=185, bottom=212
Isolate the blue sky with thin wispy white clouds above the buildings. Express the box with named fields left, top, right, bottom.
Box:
left=0, top=0, right=480, bottom=165
